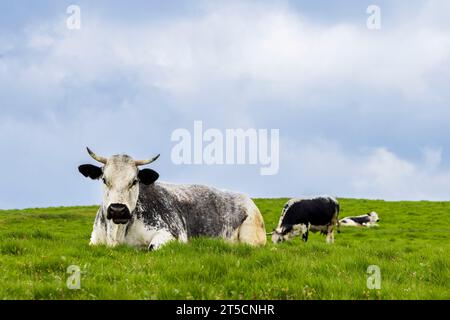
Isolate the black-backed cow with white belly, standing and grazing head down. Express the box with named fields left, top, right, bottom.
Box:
left=270, top=196, right=339, bottom=243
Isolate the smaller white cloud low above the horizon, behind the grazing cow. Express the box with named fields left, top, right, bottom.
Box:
left=281, top=140, right=450, bottom=200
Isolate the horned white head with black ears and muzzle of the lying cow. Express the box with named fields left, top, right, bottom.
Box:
left=78, top=148, right=159, bottom=224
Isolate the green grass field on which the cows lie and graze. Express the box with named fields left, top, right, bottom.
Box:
left=0, top=199, right=450, bottom=299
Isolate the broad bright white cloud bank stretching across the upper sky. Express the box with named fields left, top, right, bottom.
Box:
left=4, top=3, right=450, bottom=108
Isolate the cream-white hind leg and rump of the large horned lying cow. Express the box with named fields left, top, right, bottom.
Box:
left=237, top=199, right=267, bottom=246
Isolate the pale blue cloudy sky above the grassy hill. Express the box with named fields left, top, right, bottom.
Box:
left=0, top=0, right=450, bottom=209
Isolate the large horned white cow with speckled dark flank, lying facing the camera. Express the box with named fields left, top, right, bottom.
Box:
left=78, top=148, right=266, bottom=250
